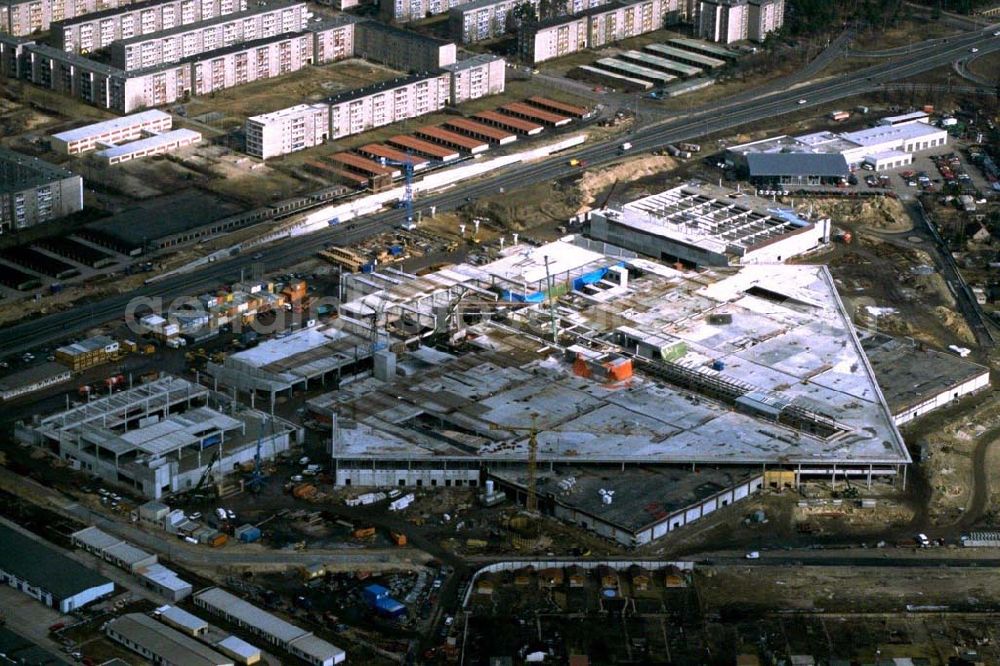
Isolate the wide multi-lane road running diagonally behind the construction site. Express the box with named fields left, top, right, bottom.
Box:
left=0, top=29, right=1000, bottom=354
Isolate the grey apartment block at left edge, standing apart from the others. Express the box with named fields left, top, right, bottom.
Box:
left=0, top=148, right=83, bottom=234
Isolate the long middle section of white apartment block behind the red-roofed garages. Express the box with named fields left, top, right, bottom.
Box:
left=327, top=72, right=451, bottom=140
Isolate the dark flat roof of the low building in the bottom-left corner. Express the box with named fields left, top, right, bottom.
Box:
left=0, top=524, right=111, bottom=599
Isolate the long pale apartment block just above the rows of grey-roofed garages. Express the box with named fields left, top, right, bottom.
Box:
left=518, top=0, right=679, bottom=63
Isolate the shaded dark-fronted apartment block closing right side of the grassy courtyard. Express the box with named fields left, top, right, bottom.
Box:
left=354, top=21, right=457, bottom=72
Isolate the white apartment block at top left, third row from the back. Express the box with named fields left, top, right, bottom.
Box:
left=111, top=2, right=312, bottom=71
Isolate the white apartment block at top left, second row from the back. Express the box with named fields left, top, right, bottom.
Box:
left=52, top=0, right=247, bottom=54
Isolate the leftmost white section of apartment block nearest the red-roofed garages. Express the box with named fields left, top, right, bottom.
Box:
left=245, top=104, right=330, bottom=160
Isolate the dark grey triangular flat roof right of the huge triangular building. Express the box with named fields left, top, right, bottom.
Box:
left=860, top=331, right=990, bottom=414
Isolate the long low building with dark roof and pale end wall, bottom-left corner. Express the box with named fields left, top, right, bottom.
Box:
left=0, top=525, right=115, bottom=613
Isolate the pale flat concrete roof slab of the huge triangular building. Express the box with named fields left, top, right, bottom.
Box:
left=326, top=245, right=910, bottom=466
